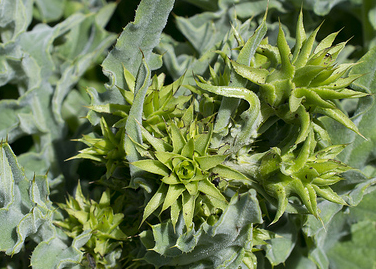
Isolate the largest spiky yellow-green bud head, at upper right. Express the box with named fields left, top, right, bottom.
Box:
left=231, top=10, right=367, bottom=144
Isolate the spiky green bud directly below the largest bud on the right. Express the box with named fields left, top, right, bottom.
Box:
left=257, top=131, right=351, bottom=223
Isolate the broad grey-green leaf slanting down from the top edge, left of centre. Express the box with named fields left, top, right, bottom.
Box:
left=102, top=0, right=174, bottom=90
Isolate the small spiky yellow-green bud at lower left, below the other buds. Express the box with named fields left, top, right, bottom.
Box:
left=55, top=181, right=127, bottom=268
